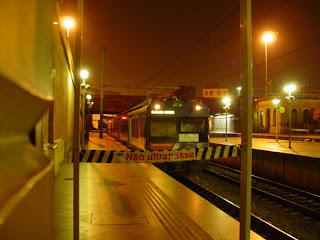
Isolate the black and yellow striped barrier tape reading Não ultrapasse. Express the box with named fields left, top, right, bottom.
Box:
left=75, top=146, right=238, bottom=163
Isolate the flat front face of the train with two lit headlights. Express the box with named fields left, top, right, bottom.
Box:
left=146, top=99, right=209, bottom=150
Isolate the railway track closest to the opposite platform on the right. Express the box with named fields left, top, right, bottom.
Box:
left=205, top=164, right=320, bottom=220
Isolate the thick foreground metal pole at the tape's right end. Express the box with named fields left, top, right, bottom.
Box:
left=240, top=0, right=252, bottom=240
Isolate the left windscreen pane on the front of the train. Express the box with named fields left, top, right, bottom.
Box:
left=150, top=118, right=177, bottom=137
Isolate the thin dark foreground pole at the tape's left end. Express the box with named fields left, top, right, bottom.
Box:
left=73, top=0, right=83, bottom=240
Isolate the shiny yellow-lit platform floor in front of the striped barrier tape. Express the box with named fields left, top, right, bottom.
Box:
left=55, top=163, right=262, bottom=240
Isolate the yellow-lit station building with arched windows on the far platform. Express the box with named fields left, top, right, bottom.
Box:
left=253, top=87, right=320, bottom=134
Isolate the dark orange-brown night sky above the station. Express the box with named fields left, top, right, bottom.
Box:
left=62, top=0, right=320, bottom=96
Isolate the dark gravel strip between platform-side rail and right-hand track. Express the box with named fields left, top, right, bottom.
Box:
left=188, top=169, right=320, bottom=240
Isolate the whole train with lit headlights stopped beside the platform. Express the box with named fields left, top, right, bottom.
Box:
left=107, top=97, right=210, bottom=150
